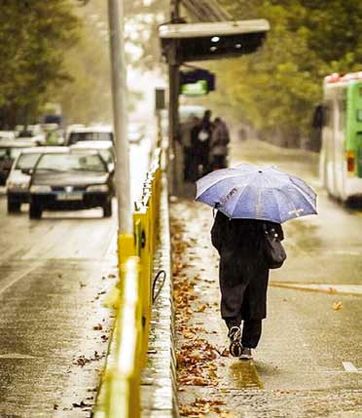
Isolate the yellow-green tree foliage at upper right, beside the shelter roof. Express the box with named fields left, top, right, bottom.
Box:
left=208, top=0, right=362, bottom=147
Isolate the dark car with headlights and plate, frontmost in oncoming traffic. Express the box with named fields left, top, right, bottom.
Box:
left=29, top=150, right=113, bottom=219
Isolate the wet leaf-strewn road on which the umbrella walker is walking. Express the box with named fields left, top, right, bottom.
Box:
left=172, top=141, right=362, bottom=418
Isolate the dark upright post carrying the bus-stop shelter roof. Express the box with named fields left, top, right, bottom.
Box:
left=168, top=0, right=180, bottom=194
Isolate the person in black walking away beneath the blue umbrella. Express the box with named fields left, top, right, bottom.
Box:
left=211, top=211, right=284, bottom=360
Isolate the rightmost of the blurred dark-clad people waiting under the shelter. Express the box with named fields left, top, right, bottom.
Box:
left=210, top=117, right=230, bottom=170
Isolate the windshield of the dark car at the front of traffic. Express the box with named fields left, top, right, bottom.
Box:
left=36, top=154, right=106, bottom=172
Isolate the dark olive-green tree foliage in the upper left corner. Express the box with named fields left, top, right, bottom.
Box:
left=0, top=0, right=78, bottom=125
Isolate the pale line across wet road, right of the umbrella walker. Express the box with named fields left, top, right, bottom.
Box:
left=270, top=281, right=362, bottom=296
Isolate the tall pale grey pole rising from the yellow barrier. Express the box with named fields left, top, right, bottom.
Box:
left=108, top=0, right=133, bottom=235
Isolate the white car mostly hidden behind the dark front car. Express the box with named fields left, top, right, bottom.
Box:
left=6, top=147, right=67, bottom=213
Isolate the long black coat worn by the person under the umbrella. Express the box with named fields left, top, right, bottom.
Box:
left=211, top=212, right=284, bottom=320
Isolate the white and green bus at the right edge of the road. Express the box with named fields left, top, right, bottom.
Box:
left=320, top=72, right=362, bottom=203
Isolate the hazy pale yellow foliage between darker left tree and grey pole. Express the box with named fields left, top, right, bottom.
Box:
left=51, top=2, right=112, bottom=124
